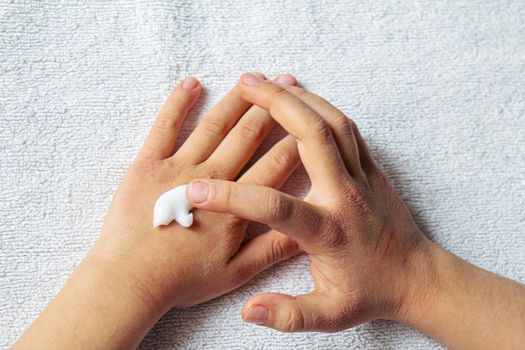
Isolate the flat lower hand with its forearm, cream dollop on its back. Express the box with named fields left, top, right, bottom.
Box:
left=14, top=75, right=299, bottom=349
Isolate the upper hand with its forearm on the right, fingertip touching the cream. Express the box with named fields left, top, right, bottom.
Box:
left=187, top=74, right=525, bottom=349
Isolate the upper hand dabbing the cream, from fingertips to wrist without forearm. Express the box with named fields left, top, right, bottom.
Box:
left=187, top=73, right=436, bottom=332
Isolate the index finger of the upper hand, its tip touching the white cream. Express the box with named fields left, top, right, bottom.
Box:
left=186, top=179, right=326, bottom=248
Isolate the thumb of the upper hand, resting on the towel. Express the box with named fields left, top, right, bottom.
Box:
left=241, top=292, right=337, bottom=332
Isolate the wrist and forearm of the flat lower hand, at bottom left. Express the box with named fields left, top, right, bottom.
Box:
left=15, top=255, right=163, bottom=349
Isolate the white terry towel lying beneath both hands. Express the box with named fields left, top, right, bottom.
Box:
left=0, top=0, right=525, bottom=349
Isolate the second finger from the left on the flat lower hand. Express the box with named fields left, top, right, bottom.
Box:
left=176, top=73, right=266, bottom=164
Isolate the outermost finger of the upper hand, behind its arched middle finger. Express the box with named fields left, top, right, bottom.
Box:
left=278, top=86, right=366, bottom=181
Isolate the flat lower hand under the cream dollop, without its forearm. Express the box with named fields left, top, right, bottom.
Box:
left=86, top=75, right=299, bottom=309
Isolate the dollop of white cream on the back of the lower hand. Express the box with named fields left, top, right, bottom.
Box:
left=153, top=185, right=193, bottom=227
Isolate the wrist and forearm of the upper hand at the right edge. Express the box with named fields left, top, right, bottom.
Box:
left=386, top=237, right=525, bottom=349
